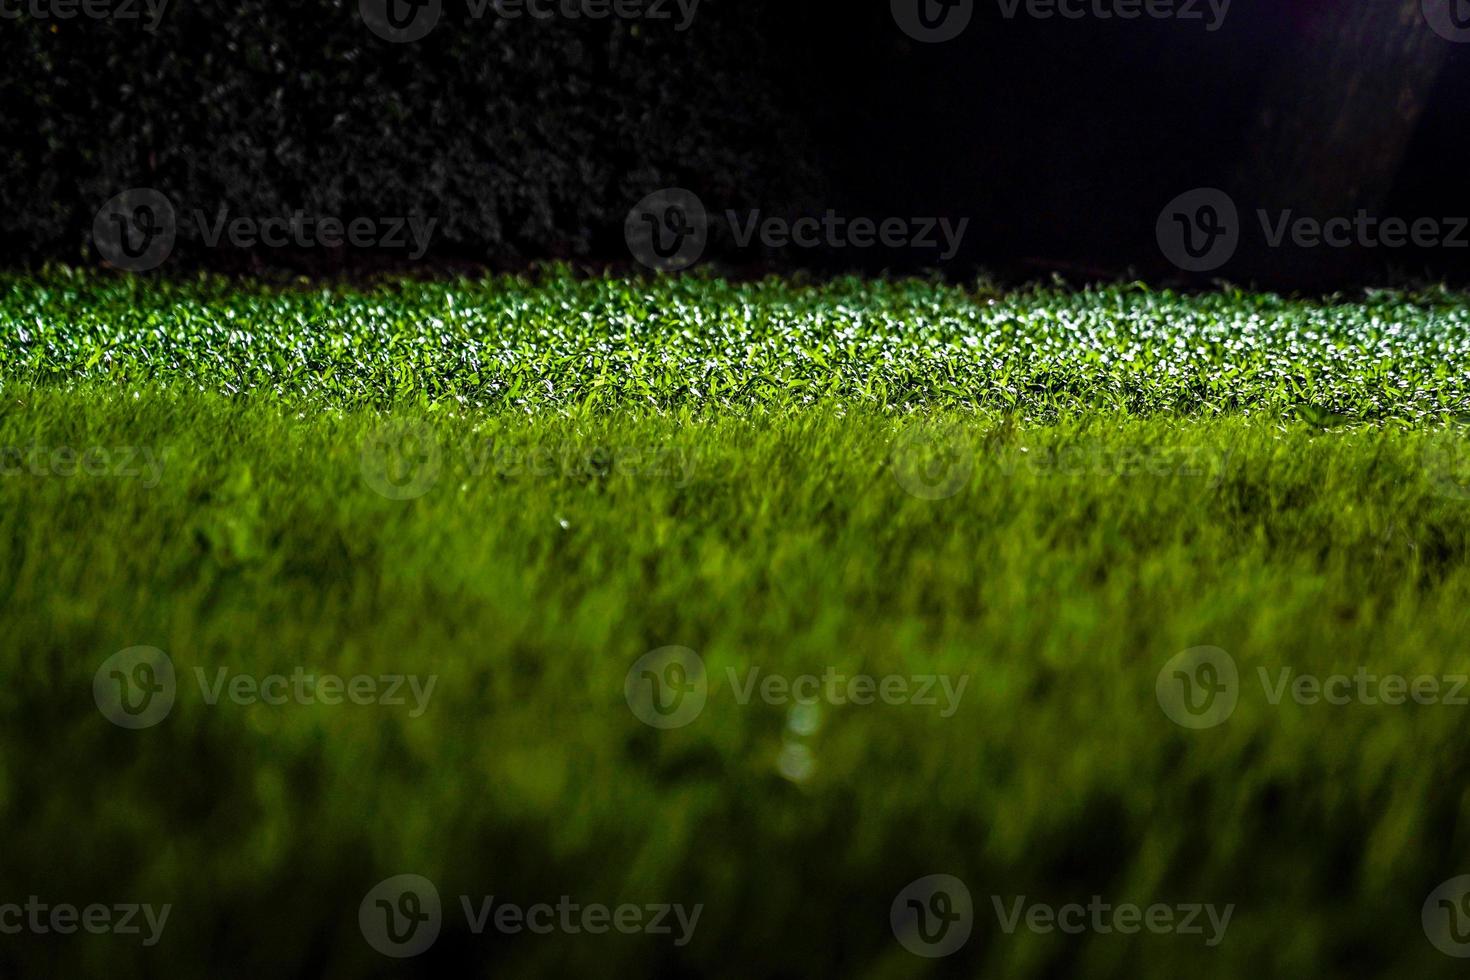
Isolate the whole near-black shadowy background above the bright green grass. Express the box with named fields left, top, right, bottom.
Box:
left=0, top=0, right=1470, bottom=287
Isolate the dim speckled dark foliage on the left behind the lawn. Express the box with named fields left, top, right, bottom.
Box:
left=0, top=0, right=806, bottom=264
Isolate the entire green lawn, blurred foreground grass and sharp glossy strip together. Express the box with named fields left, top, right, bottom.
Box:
left=0, top=269, right=1470, bottom=977
